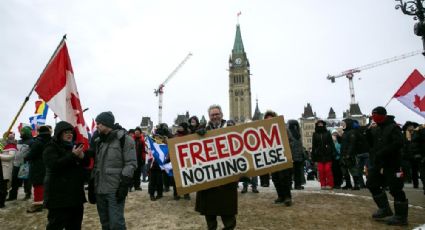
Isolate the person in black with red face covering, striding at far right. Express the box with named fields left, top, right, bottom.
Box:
left=366, top=106, right=408, bottom=225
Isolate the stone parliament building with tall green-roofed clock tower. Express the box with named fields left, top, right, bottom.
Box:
left=141, top=24, right=367, bottom=150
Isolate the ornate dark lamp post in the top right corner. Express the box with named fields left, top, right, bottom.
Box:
left=395, top=0, right=425, bottom=55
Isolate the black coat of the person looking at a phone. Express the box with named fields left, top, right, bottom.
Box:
left=43, top=141, right=88, bottom=208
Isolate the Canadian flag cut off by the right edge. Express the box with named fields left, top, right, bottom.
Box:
left=393, top=69, right=425, bottom=117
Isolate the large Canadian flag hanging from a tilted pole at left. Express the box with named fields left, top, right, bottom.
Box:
left=35, top=40, right=88, bottom=149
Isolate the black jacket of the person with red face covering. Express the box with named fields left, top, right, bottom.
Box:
left=367, top=118, right=403, bottom=170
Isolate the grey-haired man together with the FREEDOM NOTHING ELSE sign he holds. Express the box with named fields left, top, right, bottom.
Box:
left=168, top=105, right=292, bottom=229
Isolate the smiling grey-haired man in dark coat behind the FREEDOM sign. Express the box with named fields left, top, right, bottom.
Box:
left=195, top=105, right=238, bottom=229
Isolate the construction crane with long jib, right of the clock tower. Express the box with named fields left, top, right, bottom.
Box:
left=327, top=50, right=425, bottom=104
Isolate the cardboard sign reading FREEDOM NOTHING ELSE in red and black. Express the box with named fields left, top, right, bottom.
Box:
left=168, top=116, right=292, bottom=194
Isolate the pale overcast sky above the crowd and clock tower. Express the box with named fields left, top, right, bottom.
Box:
left=0, top=0, right=425, bottom=132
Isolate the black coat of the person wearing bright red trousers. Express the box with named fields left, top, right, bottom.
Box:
left=311, top=131, right=336, bottom=162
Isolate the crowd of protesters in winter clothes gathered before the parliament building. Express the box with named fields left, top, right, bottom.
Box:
left=0, top=105, right=425, bottom=229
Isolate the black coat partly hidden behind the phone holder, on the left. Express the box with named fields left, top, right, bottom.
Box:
left=24, top=134, right=51, bottom=185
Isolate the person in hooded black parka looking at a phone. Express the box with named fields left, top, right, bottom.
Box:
left=43, top=121, right=89, bottom=230
